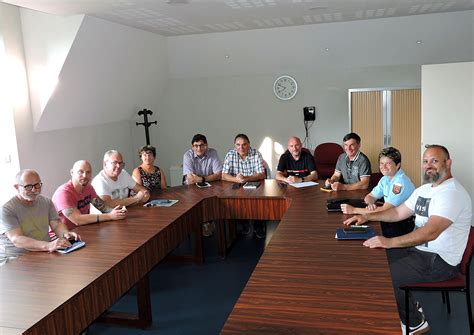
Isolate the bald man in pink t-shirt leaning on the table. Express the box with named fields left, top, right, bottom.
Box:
left=53, top=160, right=127, bottom=229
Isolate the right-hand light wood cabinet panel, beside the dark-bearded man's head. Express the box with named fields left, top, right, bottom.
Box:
left=391, top=89, right=421, bottom=186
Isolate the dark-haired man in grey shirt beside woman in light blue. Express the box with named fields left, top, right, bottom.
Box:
left=325, top=133, right=372, bottom=191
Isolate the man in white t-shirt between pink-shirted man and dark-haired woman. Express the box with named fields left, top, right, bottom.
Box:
left=92, top=150, right=150, bottom=207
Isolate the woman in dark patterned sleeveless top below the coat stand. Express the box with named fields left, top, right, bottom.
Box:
left=132, top=145, right=166, bottom=192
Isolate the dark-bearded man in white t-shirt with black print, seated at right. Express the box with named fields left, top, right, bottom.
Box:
left=344, top=145, right=472, bottom=334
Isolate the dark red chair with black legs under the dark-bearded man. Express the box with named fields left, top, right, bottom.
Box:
left=400, top=227, right=474, bottom=334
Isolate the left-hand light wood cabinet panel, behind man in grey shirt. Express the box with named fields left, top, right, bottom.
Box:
left=351, top=91, right=383, bottom=172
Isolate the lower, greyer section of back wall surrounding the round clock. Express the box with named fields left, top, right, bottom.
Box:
left=143, top=65, right=420, bottom=176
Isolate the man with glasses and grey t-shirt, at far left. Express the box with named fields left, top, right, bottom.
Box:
left=0, top=170, right=81, bottom=264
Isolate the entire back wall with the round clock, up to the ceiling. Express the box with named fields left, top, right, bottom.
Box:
left=147, top=11, right=474, bottom=176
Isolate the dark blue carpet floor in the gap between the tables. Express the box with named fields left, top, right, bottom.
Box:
left=88, top=222, right=277, bottom=335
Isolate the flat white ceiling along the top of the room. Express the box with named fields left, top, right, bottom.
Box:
left=3, top=0, right=474, bottom=36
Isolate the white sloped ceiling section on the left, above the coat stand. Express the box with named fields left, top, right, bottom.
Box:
left=22, top=12, right=167, bottom=131
